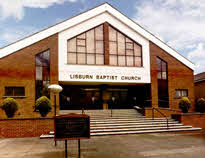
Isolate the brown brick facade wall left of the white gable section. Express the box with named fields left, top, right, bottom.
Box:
left=0, top=34, right=58, bottom=118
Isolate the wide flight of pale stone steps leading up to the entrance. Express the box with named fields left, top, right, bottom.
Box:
left=41, top=109, right=201, bottom=139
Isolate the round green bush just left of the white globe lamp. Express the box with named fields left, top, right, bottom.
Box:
left=36, top=96, right=51, bottom=117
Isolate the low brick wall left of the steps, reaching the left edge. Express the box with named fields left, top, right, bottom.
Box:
left=0, top=118, right=54, bottom=138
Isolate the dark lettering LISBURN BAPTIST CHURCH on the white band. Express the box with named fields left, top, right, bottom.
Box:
left=69, top=74, right=141, bottom=81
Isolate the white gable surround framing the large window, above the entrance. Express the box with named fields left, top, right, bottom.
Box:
left=58, top=12, right=151, bottom=83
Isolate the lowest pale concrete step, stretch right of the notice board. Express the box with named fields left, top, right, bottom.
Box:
left=91, top=128, right=201, bottom=136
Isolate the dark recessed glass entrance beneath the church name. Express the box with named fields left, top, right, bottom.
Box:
left=60, top=85, right=150, bottom=110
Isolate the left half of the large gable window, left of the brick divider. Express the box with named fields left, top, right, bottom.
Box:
left=67, top=25, right=104, bottom=65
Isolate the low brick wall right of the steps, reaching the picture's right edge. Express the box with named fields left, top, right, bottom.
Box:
left=172, top=113, right=205, bottom=129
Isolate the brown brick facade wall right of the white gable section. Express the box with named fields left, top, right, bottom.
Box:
left=150, top=42, right=195, bottom=111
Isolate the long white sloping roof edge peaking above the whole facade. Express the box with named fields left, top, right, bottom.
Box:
left=0, top=3, right=194, bottom=70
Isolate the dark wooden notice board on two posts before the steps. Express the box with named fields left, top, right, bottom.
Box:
left=54, top=114, right=90, bottom=140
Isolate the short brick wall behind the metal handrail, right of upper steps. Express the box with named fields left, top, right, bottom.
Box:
left=144, top=108, right=181, bottom=118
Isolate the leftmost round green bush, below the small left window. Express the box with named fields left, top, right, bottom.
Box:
left=1, top=98, right=18, bottom=118
